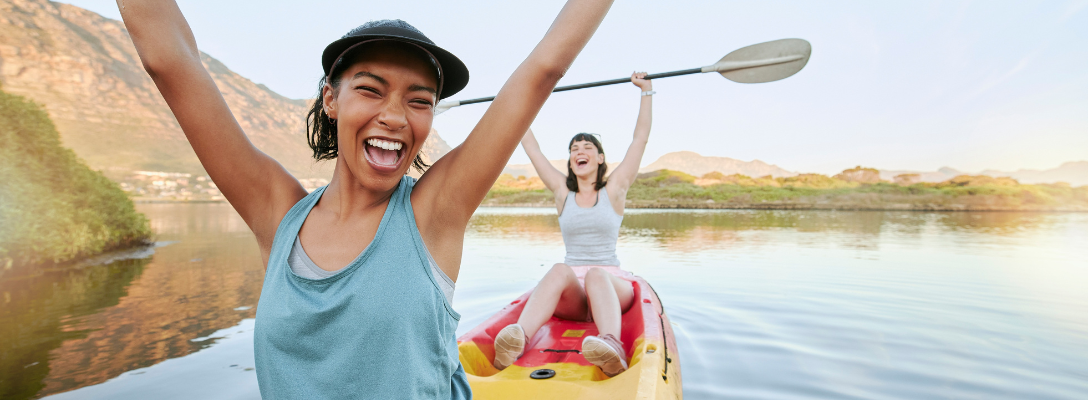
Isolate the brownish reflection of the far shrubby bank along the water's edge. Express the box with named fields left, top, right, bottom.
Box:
left=469, top=209, right=1070, bottom=251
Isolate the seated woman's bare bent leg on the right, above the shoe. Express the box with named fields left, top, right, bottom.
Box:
left=587, top=268, right=634, bottom=338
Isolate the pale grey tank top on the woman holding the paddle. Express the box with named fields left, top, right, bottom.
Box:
left=559, top=188, right=623, bottom=266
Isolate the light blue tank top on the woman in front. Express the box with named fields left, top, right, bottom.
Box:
left=254, top=176, right=472, bottom=400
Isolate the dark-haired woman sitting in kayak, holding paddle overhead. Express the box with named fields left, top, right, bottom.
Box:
left=494, top=73, right=654, bottom=376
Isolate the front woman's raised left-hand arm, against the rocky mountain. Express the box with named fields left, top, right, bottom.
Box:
left=118, top=0, right=306, bottom=246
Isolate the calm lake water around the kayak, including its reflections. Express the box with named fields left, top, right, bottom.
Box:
left=0, top=203, right=1088, bottom=399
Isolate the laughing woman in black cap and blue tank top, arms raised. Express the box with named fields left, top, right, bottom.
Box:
left=118, top=0, right=611, bottom=399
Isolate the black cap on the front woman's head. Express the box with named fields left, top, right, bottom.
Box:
left=321, top=20, right=469, bottom=99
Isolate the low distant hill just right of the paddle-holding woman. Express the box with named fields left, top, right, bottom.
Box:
left=639, top=151, right=798, bottom=177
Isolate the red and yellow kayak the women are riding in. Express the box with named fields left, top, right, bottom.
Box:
left=457, top=266, right=683, bottom=399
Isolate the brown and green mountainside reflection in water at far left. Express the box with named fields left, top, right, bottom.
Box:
left=0, top=204, right=264, bottom=399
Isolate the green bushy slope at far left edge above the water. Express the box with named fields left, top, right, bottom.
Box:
left=0, top=85, right=151, bottom=270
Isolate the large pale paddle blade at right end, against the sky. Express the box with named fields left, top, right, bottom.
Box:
left=707, top=39, right=813, bottom=84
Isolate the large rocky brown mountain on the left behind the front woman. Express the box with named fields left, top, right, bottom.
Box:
left=0, top=0, right=448, bottom=177
